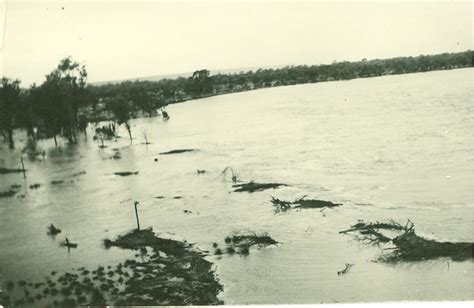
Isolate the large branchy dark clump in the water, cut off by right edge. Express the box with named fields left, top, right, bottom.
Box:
left=339, top=220, right=474, bottom=262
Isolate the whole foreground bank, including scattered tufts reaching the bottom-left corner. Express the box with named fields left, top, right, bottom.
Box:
left=0, top=229, right=222, bottom=307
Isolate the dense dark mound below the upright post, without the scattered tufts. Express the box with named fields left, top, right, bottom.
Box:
left=104, top=229, right=222, bottom=305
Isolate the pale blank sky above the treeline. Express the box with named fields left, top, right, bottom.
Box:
left=0, top=0, right=474, bottom=87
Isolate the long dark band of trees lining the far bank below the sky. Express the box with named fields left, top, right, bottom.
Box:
left=0, top=50, right=474, bottom=148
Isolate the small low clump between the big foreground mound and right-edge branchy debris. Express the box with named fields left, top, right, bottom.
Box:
left=220, top=231, right=278, bottom=255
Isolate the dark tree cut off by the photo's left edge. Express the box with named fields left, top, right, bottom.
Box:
left=0, top=78, right=20, bottom=149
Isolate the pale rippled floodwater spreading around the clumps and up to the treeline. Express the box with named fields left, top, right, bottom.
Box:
left=0, top=69, right=474, bottom=304
